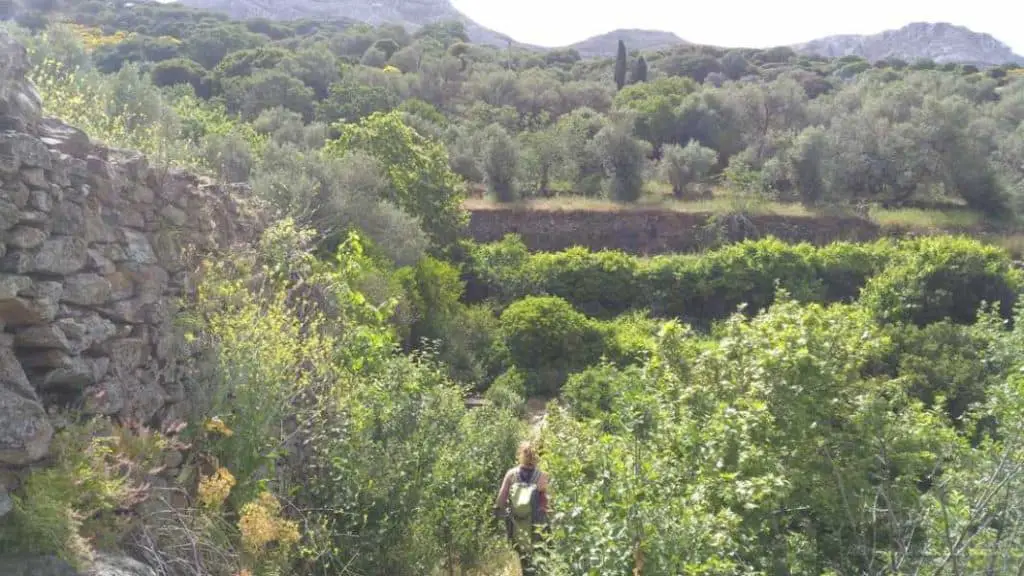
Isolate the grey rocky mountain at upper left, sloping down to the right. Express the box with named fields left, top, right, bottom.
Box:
left=178, top=0, right=516, bottom=46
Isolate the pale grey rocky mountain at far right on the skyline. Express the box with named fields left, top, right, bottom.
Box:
left=793, top=23, right=1024, bottom=66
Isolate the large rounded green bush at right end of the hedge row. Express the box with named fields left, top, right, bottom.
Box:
left=861, top=237, right=1021, bottom=326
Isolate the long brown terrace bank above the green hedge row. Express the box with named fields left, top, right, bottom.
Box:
left=469, top=207, right=892, bottom=255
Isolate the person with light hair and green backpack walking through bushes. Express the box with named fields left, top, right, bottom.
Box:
left=495, top=441, right=548, bottom=576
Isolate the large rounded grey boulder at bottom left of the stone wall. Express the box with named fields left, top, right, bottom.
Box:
left=0, top=387, right=53, bottom=463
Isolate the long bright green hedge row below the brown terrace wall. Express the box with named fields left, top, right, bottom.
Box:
left=464, top=231, right=1022, bottom=327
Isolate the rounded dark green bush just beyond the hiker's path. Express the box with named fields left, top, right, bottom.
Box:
left=501, top=296, right=603, bottom=396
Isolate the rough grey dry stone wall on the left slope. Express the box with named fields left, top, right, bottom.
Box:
left=0, top=31, right=260, bottom=479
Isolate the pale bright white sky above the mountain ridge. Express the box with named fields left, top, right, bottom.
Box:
left=452, top=0, right=1024, bottom=54
